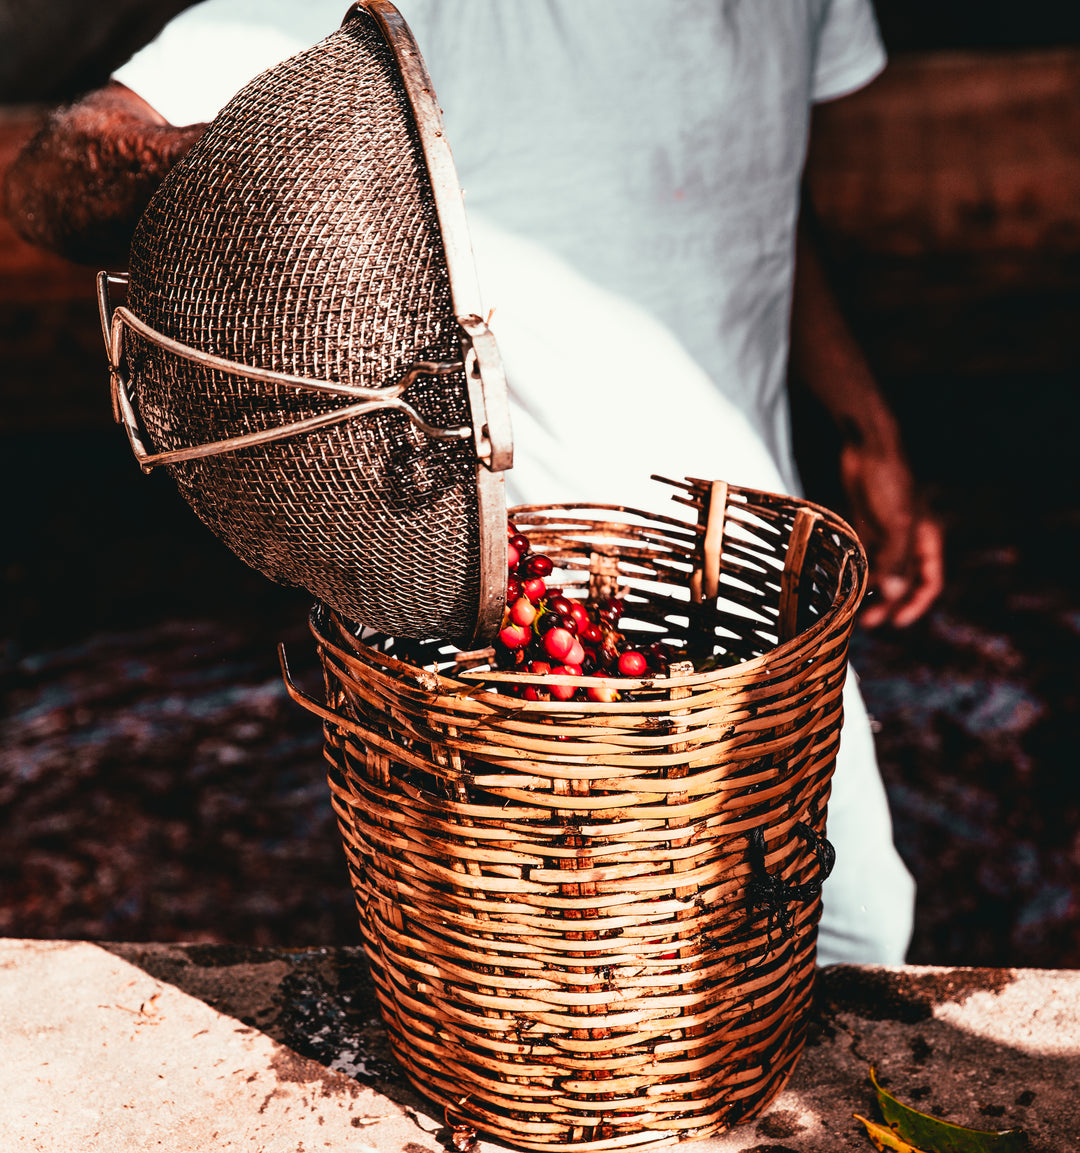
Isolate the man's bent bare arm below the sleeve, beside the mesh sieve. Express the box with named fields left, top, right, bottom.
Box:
left=3, top=82, right=205, bottom=269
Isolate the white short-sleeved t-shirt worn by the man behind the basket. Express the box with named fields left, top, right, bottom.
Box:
left=116, top=0, right=884, bottom=504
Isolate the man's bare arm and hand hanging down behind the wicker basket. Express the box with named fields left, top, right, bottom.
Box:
left=792, top=202, right=944, bottom=627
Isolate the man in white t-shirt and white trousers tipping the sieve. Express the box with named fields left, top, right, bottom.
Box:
left=8, top=0, right=942, bottom=963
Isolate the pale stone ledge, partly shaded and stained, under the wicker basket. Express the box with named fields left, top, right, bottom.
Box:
left=0, top=940, right=1080, bottom=1153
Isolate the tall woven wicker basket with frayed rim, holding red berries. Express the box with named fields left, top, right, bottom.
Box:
left=286, top=482, right=866, bottom=1151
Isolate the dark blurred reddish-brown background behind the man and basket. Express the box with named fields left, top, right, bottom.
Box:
left=0, top=0, right=1080, bottom=967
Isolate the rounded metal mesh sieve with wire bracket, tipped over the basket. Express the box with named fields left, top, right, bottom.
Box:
left=98, top=0, right=512, bottom=648
